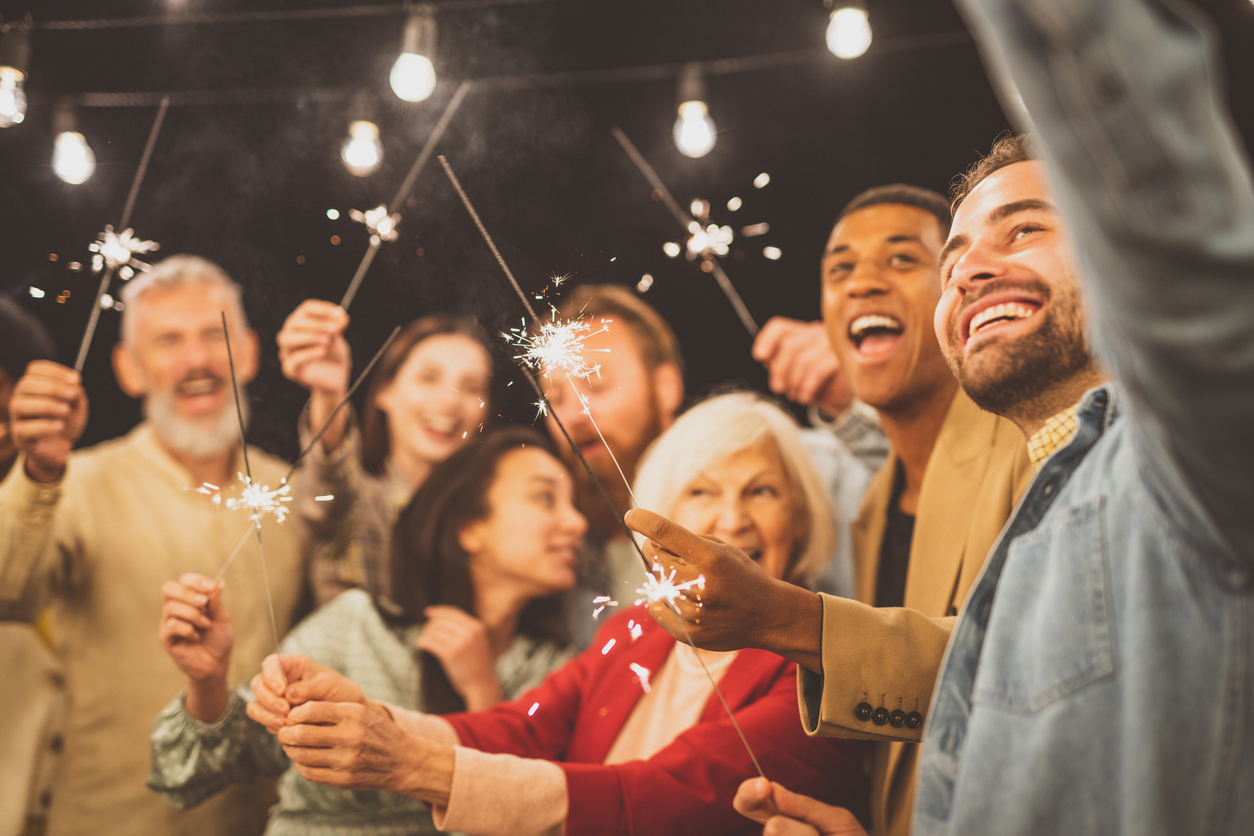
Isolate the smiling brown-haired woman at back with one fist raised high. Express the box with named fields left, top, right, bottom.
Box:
left=277, top=300, right=492, bottom=605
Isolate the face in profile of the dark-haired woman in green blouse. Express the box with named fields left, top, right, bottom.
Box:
left=459, top=447, right=588, bottom=597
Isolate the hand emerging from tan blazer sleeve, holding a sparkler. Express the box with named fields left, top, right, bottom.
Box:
left=626, top=509, right=823, bottom=672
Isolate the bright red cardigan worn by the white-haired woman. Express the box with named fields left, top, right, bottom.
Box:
left=445, top=607, right=870, bottom=836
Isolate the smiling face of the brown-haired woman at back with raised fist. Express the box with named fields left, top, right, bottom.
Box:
left=375, top=333, right=492, bottom=464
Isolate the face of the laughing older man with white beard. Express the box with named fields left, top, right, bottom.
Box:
left=124, top=285, right=257, bottom=456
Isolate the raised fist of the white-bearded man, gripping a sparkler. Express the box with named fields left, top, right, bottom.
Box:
left=9, top=360, right=88, bottom=484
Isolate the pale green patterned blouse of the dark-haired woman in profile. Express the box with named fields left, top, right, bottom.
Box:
left=148, top=589, right=573, bottom=836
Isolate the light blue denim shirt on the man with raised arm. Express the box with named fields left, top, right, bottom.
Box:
left=914, top=0, right=1254, bottom=836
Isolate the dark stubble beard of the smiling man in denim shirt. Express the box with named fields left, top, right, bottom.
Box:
left=946, top=282, right=1095, bottom=420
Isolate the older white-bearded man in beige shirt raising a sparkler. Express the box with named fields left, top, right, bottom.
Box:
left=0, top=256, right=303, bottom=836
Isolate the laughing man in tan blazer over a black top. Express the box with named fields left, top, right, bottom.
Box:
left=677, top=185, right=1032, bottom=836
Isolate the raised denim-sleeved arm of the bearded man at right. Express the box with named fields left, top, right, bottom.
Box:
left=959, top=0, right=1254, bottom=577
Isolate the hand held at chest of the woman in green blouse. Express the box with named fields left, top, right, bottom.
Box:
left=415, top=605, right=503, bottom=711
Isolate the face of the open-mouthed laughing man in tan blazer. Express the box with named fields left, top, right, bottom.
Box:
left=823, top=203, right=952, bottom=411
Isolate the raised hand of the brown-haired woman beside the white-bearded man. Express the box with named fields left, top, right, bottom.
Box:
left=276, top=300, right=352, bottom=450
